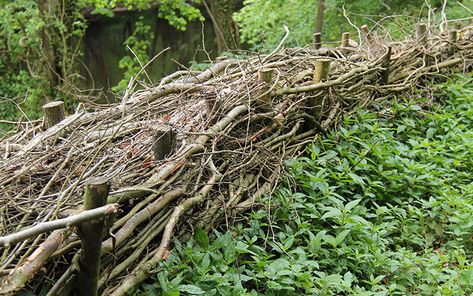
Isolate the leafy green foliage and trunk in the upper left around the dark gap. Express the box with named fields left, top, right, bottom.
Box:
left=0, top=0, right=203, bottom=126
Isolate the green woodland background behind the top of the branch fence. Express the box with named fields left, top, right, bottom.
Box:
left=0, top=0, right=473, bottom=133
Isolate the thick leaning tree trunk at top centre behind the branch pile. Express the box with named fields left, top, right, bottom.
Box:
left=207, top=0, right=240, bottom=54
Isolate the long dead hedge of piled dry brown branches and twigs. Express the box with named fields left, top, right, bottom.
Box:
left=0, top=23, right=473, bottom=295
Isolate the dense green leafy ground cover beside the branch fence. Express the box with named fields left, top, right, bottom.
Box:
left=137, top=77, right=473, bottom=295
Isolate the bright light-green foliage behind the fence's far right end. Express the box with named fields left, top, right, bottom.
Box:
left=234, top=0, right=473, bottom=51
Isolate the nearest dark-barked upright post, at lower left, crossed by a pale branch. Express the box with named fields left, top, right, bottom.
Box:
left=77, top=177, right=110, bottom=296
